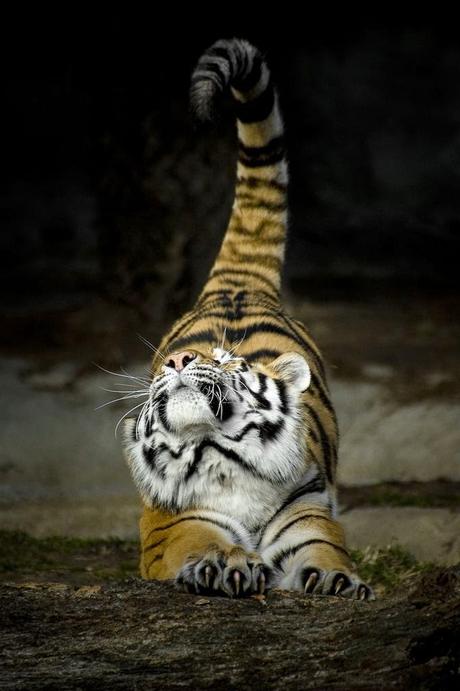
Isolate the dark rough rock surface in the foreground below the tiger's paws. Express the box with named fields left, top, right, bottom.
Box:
left=0, top=569, right=460, bottom=691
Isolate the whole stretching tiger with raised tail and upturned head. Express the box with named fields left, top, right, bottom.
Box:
left=125, top=39, right=373, bottom=599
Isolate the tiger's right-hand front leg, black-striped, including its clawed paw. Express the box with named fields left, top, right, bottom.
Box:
left=259, top=502, right=374, bottom=600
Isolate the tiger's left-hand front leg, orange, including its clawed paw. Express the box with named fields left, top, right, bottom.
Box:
left=140, top=507, right=268, bottom=597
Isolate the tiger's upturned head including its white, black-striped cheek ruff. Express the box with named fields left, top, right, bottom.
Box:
left=126, top=348, right=310, bottom=509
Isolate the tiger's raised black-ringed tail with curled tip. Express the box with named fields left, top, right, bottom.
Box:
left=191, top=39, right=288, bottom=299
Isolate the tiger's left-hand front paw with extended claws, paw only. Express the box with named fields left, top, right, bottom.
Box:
left=175, top=545, right=269, bottom=597
